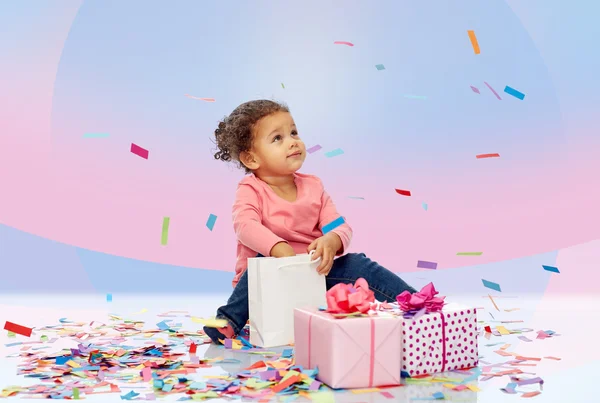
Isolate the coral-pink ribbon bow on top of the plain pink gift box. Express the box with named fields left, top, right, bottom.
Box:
left=327, top=278, right=375, bottom=313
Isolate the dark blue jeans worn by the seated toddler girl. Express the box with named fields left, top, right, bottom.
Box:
left=209, top=253, right=416, bottom=342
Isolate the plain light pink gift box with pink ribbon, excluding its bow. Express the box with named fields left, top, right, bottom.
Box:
left=294, top=309, right=402, bottom=389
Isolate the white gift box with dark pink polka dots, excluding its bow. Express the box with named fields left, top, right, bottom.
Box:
left=399, top=303, right=479, bottom=376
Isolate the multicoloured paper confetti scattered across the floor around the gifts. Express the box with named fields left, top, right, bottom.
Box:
left=0, top=302, right=560, bottom=402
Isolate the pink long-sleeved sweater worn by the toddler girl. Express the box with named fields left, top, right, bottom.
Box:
left=233, top=173, right=352, bottom=287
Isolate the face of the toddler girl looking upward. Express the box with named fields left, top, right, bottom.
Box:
left=243, top=112, right=306, bottom=176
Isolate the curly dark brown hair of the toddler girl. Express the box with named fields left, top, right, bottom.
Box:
left=214, top=99, right=290, bottom=173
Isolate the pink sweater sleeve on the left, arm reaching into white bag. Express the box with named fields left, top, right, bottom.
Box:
left=233, top=184, right=287, bottom=256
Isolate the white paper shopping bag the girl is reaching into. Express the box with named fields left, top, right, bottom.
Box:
left=248, top=251, right=327, bottom=347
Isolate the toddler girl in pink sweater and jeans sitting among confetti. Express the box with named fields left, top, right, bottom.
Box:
left=204, top=100, right=415, bottom=343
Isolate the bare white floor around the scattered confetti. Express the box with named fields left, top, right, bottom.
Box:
left=0, top=294, right=600, bottom=403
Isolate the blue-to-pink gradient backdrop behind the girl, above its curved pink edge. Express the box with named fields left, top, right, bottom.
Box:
left=0, top=0, right=600, bottom=292
